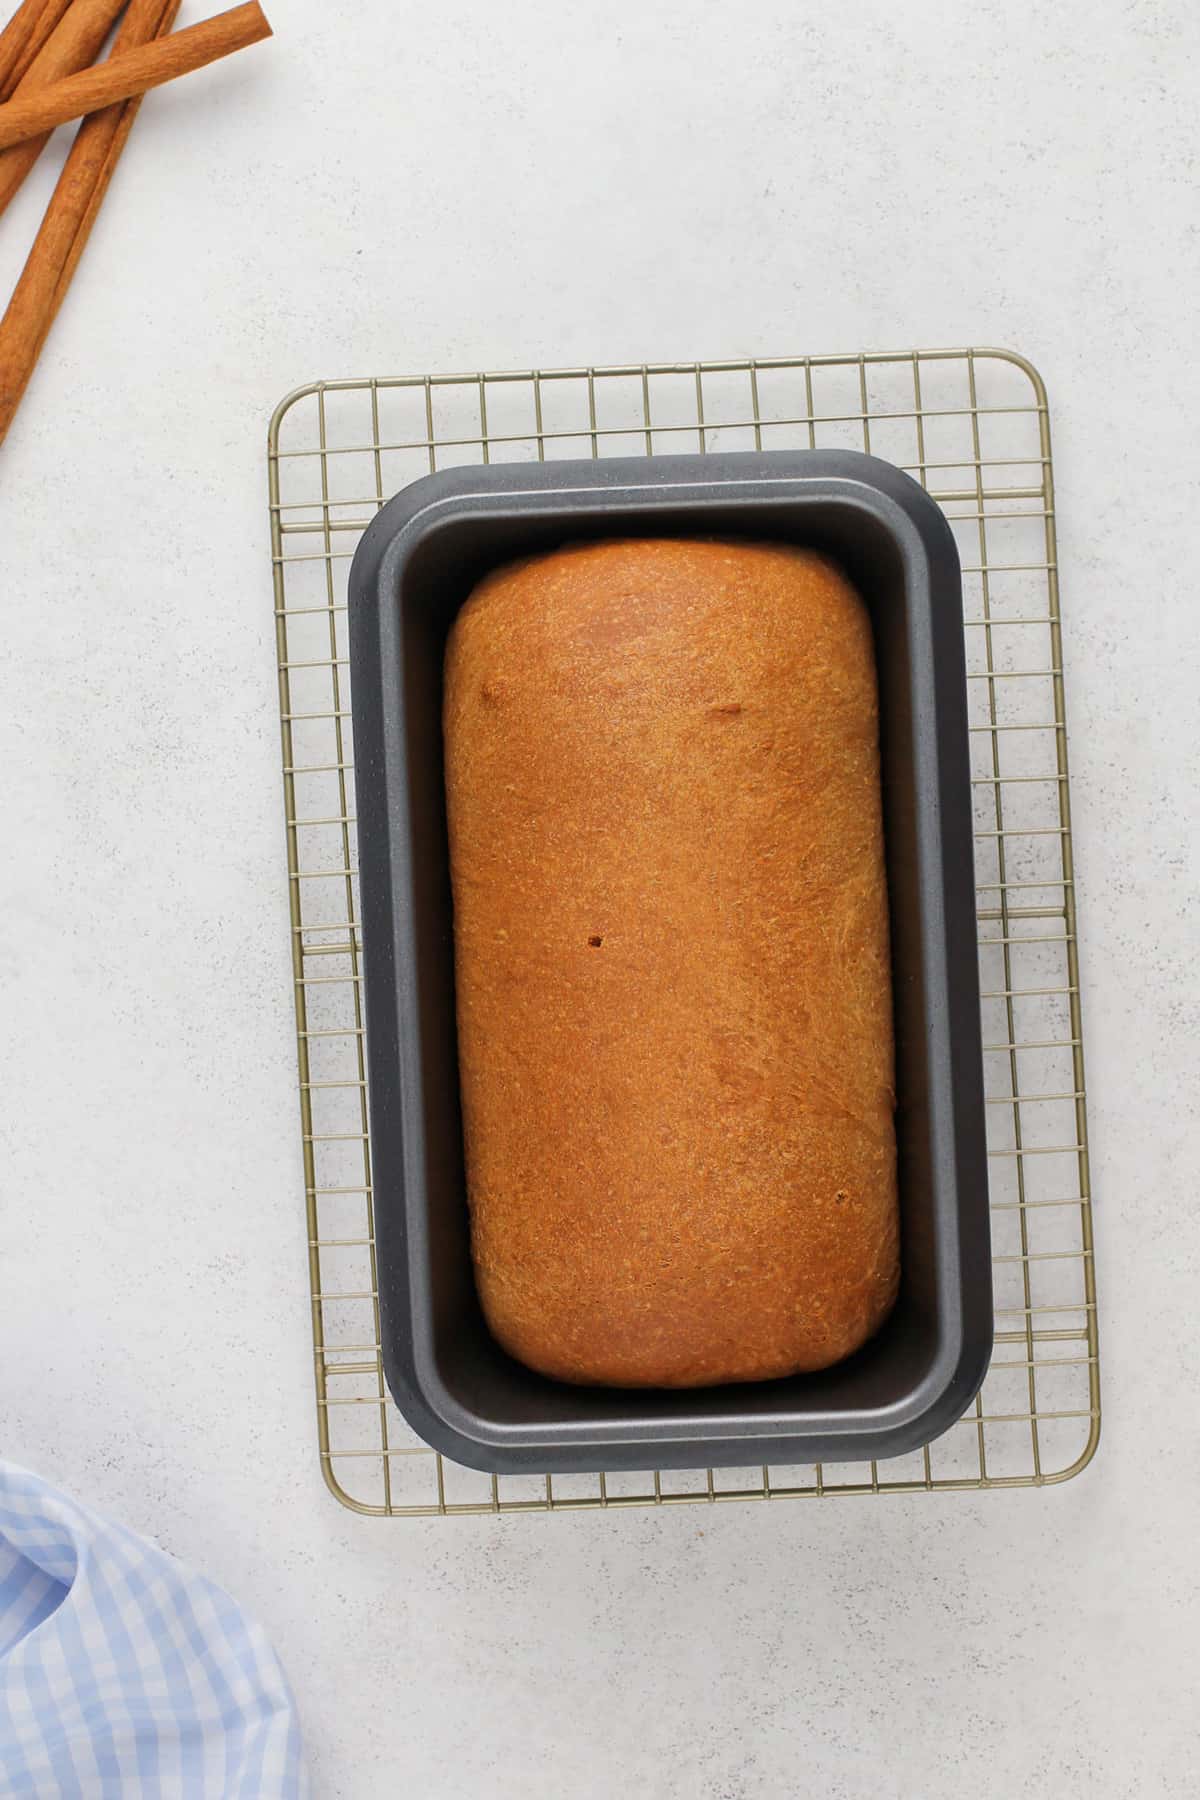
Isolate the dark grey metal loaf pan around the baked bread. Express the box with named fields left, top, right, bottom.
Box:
left=349, top=450, right=991, bottom=1474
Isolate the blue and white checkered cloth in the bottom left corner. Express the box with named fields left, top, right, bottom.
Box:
left=0, top=1462, right=308, bottom=1800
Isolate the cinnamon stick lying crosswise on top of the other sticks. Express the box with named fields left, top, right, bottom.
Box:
left=0, top=0, right=272, bottom=151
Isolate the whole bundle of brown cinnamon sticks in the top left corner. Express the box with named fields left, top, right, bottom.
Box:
left=0, top=0, right=270, bottom=443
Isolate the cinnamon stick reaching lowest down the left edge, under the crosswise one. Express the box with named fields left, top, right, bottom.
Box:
left=0, top=0, right=180, bottom=441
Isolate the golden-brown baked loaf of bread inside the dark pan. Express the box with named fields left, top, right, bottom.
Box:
left=444, top=540, right=898, bottom=1388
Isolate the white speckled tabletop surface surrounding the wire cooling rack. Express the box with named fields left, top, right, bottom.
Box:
left=0, top=0, right=1200, bottom=1800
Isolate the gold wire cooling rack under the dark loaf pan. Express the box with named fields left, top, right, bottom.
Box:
left=268, top=349, right=1099, bottom=1516
